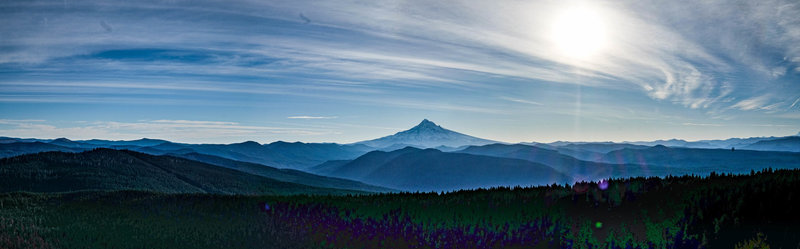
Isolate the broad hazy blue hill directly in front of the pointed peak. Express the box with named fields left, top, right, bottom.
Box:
left=314, top=147, right=571, bottom=191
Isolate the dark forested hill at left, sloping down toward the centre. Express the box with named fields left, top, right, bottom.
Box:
left=0, top=149, right=360, bottom=194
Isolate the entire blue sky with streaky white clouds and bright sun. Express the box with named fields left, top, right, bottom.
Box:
left=0, top=0, right=800, bottom=143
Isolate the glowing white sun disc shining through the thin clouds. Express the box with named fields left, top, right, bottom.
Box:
left=550, top=7, right=607, bottom=60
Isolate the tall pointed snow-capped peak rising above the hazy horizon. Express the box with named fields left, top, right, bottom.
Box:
left=356, top=119, right=497, bottom=148
